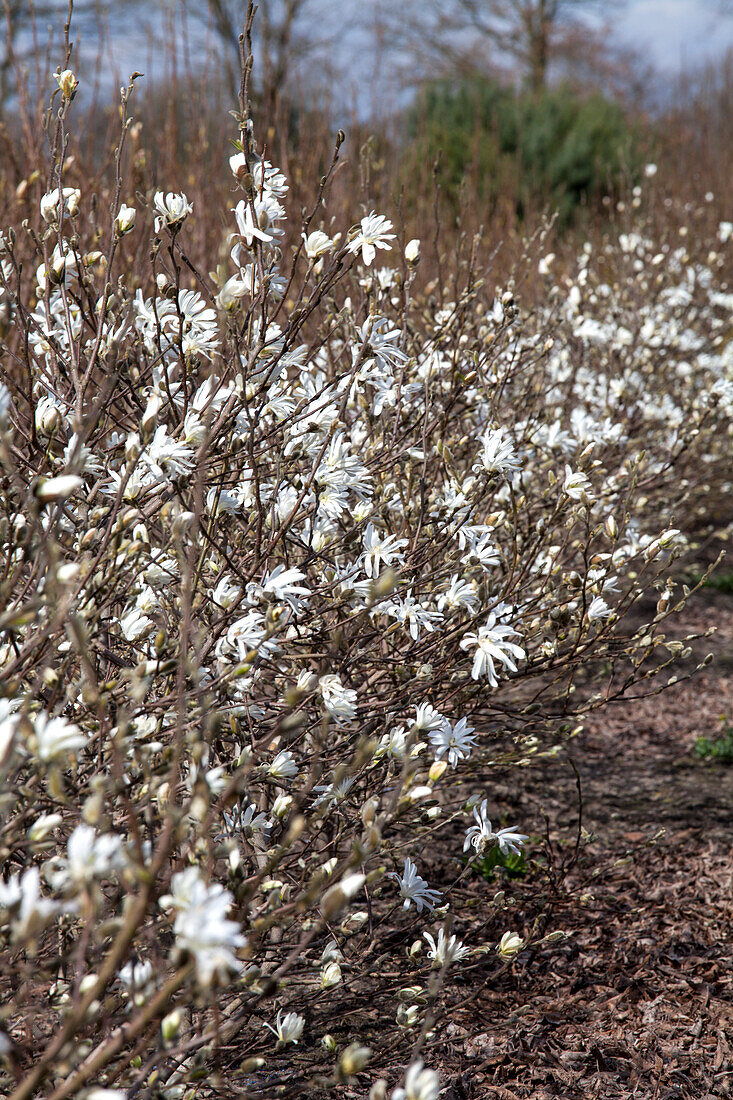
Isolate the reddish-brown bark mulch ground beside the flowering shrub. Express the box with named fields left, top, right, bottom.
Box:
left=435, top=589, right=733, bottom=1100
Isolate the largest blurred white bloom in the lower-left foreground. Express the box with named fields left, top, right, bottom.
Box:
left=160, top=867, right=247, bottom=986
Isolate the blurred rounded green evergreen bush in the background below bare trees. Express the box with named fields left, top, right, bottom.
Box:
left=403, top=77, right=643, bottom=226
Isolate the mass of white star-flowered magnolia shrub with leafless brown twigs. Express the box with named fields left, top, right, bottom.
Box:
left=0, top=34, right=733, bottom=1100
